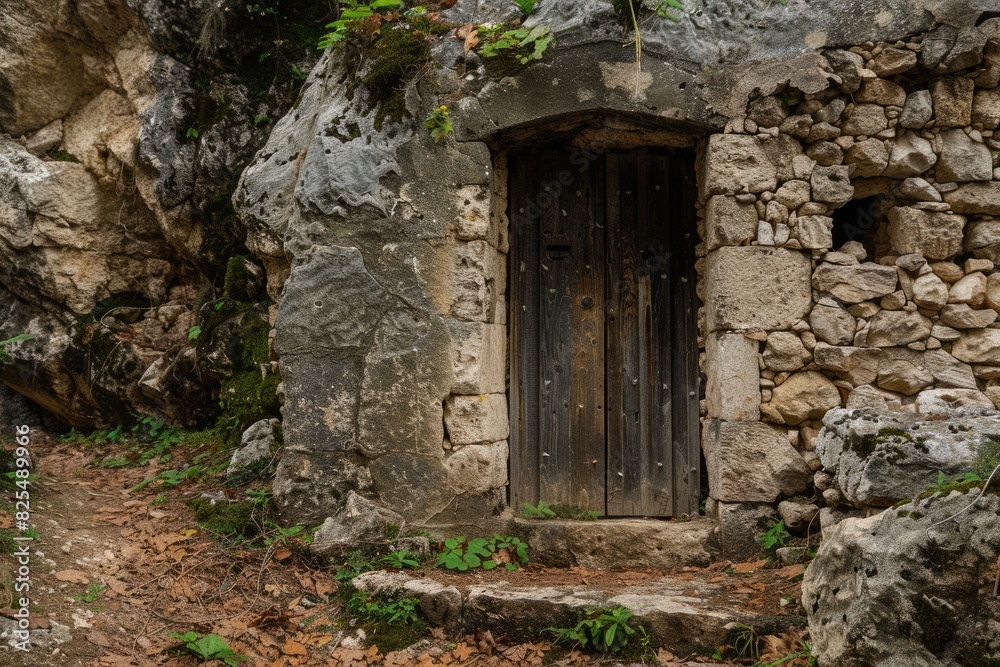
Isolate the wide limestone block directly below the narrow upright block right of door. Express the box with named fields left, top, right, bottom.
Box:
left=702, top=420, right=812, bottom=503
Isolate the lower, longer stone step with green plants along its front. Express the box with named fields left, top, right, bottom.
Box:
left=353, top=571, right=806, bottom=656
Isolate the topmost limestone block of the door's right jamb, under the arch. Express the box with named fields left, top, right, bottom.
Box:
left=702, top=134, right=777, bottom=195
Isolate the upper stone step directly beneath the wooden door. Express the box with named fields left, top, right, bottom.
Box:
left=509, top=517, right=719, bottom=570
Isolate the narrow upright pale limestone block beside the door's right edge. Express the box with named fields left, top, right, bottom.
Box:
left=705, top=333, right=760, bottom=421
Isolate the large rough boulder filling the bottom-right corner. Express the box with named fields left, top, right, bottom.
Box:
left=802, top=489, right=1000, bottom=667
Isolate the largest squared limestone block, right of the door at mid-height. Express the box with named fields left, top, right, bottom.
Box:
left=705, top=246, right=812, bottom=331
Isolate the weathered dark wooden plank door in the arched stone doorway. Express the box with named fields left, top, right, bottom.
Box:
left=509, top=155, right=700, bottom=516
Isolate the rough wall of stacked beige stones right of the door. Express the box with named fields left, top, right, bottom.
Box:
left=698, top=19, right=1000, bottom=536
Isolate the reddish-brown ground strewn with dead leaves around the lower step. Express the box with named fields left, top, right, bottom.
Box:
left=0, top=438, right=802, bottom=667
